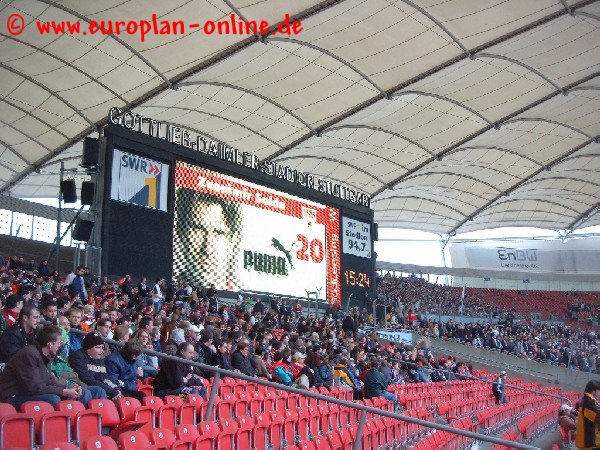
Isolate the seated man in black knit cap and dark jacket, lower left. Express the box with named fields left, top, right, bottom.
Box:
left=69, top=331, right=122, bottom=400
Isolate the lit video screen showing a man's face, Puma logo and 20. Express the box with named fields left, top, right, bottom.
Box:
left=173, top=162, right=340, bottom=303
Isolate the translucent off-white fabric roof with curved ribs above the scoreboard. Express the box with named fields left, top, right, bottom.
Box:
left=0, top=0, right=600, bottom=235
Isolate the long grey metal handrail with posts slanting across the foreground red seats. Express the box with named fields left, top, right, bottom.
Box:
left=71, top=329, right=541, bottom=450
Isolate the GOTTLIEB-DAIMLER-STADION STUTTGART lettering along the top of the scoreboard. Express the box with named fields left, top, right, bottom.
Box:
left=108, top=107, right=371, bottom=208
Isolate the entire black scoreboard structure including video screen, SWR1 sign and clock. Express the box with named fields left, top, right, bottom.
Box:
left=101, top=122, right=375, bottom=307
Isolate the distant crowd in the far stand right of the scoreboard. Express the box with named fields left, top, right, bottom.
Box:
left=378, top=274, right=600, bottom=373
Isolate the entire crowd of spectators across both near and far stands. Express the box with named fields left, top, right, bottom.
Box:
left=0, top=251, right=600, bottom=414
